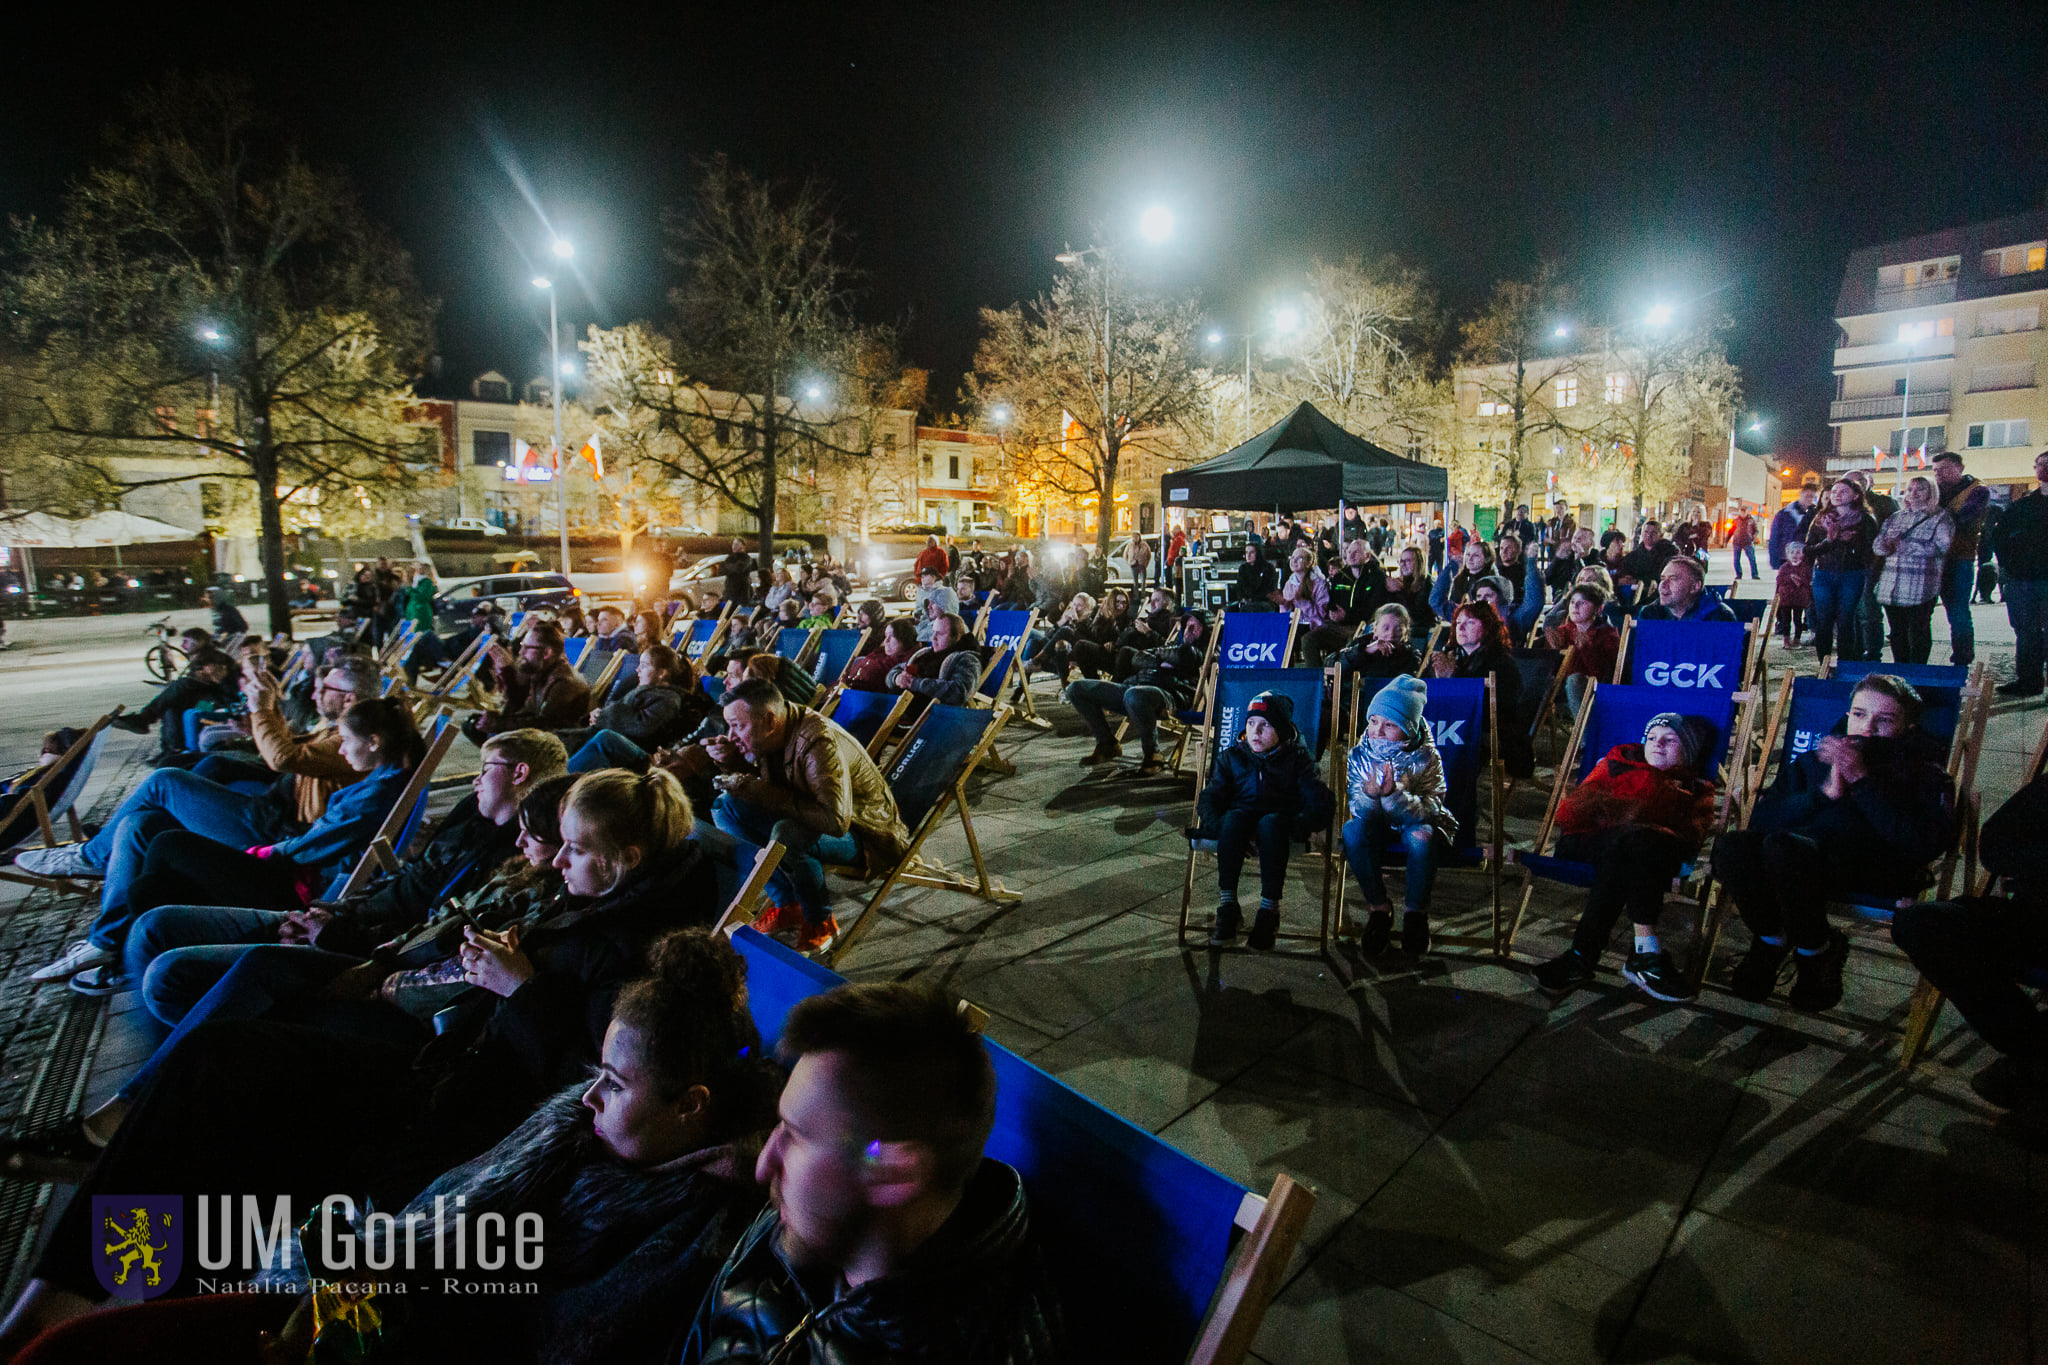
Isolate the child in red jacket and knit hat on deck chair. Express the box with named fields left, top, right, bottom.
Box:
left=1536, top=710, right=1714, bottom=1001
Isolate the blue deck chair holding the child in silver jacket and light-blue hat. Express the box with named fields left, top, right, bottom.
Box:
left=1323, top=677, right=1505, bottom=954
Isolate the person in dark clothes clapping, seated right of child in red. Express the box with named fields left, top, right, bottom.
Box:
left=1714, top=673, right=1956, bottom=1009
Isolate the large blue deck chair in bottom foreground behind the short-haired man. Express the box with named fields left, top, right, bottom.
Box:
left=733, top=929, right=1315, bottom=1365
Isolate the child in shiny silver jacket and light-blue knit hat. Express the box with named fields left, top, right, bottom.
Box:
left=1343, top=677, right=1458, bottom=954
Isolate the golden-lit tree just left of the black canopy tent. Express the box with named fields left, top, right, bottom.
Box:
left=965, top=248, right=1208, bottom=555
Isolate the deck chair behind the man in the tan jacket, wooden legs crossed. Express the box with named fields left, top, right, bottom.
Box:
left=825, top=702, right=1022, bottom=966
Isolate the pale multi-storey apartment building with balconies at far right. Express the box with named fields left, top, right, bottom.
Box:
left=1827, top=209, right=2048, bottom=493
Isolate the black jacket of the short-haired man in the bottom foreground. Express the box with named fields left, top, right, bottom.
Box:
left=682, top=1158, right=1071, bottom=1365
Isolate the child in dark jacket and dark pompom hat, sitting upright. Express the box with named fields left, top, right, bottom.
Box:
left=1188, top=692, right=1337, bottom=950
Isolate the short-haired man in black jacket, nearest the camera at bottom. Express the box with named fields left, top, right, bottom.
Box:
left=682, top=982, right=1069, bottom=1365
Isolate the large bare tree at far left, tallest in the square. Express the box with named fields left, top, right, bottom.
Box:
left=4, top=80, right=432, bottom=630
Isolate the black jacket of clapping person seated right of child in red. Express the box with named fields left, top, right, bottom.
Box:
left=1749, top=720, right=1956, bottom=894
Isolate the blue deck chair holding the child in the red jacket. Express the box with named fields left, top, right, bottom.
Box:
left=1501, top=679, right=1755, bottom=965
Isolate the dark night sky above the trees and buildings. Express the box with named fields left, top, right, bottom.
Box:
left=0, top=0, right=2048, bottom=474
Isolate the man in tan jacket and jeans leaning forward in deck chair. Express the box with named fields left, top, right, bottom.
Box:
left=702, top=677, right=909, bottom=952
